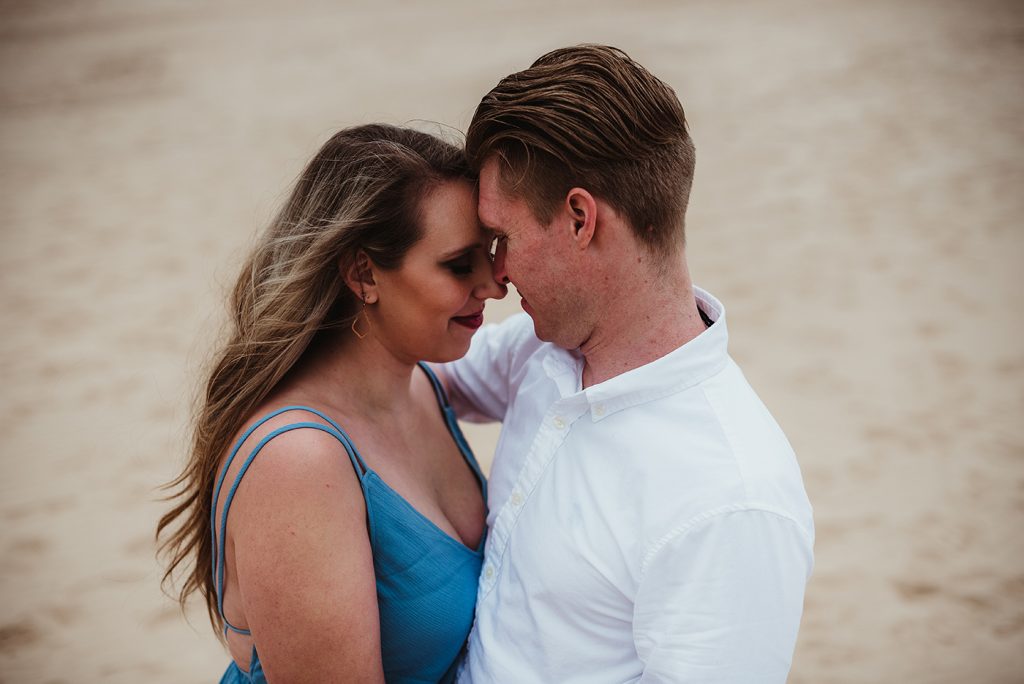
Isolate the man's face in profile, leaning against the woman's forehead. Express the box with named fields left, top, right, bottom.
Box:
left=477, top=158, right=588, bottom=349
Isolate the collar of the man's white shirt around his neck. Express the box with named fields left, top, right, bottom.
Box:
left=544, top=287, right=729, bottom=422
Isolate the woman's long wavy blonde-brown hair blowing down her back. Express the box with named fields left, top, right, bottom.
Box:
left=156, top=124, right=472, bottom=633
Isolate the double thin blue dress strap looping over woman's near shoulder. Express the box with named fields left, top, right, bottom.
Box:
left=210, top=405, right=369, bottom=636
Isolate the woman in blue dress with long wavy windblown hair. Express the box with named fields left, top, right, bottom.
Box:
left=158, top=125, right=505, bottom=682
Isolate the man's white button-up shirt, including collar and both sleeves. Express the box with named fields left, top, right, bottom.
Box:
left=445, top=290, right=814, bottom=684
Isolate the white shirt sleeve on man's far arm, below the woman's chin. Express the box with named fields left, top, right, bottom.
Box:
left=441, top=313, right=540, bottom=423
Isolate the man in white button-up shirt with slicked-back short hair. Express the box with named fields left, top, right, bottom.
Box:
left=444, top=45, right=814, bottom=683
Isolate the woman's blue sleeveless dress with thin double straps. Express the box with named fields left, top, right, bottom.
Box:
left=211, top=364, right=486, bottom=684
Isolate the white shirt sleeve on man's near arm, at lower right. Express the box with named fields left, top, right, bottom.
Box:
left=634, top=508, right=813, bottom=684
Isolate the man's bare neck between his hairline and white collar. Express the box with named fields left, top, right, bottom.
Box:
left=580, top=254, right=706, bottom=387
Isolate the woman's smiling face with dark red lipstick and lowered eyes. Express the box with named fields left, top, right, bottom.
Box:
left=366, top=181, right=506, bottom=362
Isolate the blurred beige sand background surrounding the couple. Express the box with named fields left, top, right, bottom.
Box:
left=0, top=0, right=1024, bottom=683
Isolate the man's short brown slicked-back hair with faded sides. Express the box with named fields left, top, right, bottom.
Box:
left=466, top=45, right=695, bottom=254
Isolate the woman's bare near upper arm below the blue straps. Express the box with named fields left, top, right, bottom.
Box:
left=227, top=429, right=384, bottom=682
